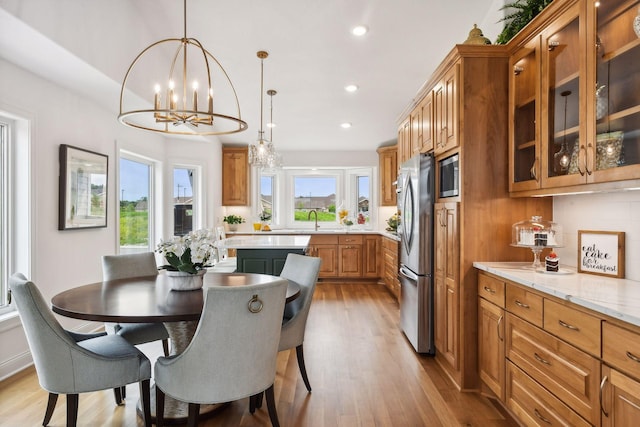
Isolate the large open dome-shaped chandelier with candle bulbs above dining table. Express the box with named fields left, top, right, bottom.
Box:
left=118, top=0, right=247, bottom=135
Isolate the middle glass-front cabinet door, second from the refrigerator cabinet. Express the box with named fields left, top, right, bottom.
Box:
left=542, top=2, right=587, bottom=188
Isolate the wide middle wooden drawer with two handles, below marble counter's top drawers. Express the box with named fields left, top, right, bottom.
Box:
left=506, top=313, right=600, bottom=425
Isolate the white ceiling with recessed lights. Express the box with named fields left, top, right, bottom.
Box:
left=0, top=0, right=504, bottom=151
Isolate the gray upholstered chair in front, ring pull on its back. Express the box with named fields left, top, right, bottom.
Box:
left=154, top=279, right=287, bottom=427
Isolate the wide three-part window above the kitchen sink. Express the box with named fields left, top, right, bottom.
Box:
left=254, top=168, right=375, bottom=229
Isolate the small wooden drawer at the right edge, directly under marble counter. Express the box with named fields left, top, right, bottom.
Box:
left=602, top=322, right=640, bottom=378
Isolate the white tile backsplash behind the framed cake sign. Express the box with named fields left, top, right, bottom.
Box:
left=553, top=191, right=640, bottom=281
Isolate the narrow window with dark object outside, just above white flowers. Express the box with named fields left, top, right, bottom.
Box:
left=173, top=167, right=198, bottom=236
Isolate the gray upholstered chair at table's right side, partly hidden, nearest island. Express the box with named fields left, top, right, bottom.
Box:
left=278, top=254, right=322, bottom=391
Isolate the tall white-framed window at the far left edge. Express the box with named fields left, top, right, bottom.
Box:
left=0, top=112, right=31, bottom=315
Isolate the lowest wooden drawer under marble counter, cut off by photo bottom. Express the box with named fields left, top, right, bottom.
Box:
left=506, top=362, right=591, bottom=427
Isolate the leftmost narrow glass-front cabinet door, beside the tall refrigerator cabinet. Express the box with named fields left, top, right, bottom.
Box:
left=509, top=37, right=541, bottom=191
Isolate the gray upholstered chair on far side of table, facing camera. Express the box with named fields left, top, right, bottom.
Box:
left=102, top=252, right=169, bottom=356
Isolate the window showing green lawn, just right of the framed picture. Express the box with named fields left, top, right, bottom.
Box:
left=119, top=153, right=154, bottom=253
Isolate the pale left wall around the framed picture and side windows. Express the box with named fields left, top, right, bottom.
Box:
left=0, top=59, right=221, bottom=378
